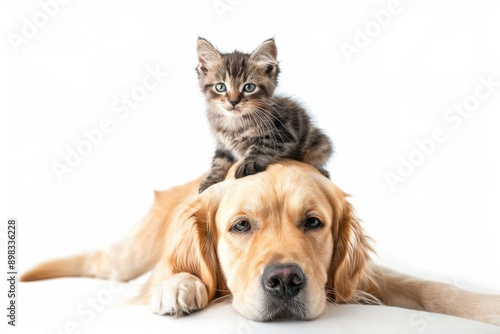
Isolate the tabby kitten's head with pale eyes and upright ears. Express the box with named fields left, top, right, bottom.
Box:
left=197, top=38, right=279, bottom=117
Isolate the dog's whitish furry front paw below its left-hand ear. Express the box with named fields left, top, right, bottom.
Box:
left=151, top=273, right=208, bottom=317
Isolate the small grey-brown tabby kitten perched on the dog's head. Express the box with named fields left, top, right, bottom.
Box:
left=197, top=38, right=333, bottom=193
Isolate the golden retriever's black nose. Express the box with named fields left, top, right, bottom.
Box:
left=262, top=264, right=305, bottom=299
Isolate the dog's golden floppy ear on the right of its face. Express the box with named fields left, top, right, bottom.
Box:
left=327, top=184, right=372, bottom=302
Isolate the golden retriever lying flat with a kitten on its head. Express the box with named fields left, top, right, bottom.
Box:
left=22, top=161, right=500, bottom=325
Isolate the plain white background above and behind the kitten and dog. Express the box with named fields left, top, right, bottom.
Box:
left=0, top=0, right=500, bottom=332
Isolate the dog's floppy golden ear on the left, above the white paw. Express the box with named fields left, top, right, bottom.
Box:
left=168, top=184, right=225, bottom=300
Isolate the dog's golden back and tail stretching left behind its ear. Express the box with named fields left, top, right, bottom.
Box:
left=21, top=178, right=201, bottom=282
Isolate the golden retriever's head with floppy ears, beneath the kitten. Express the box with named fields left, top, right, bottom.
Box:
left=173, top=161, right=370, bottom=321
